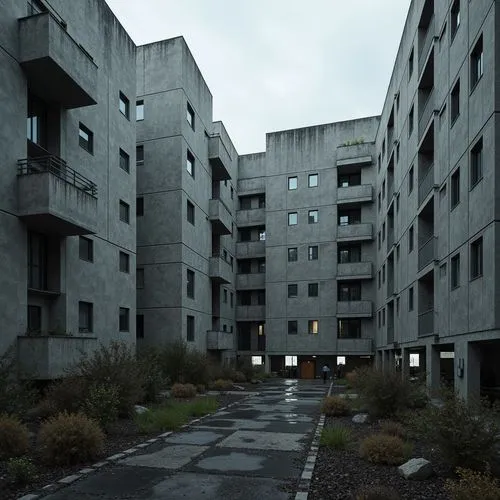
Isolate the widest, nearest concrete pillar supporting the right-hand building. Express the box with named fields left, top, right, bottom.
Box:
left=454, top=341, right=481, bottom=400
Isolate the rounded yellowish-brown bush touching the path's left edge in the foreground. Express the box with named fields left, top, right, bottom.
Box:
left=38, top=413, right=104, bottom=465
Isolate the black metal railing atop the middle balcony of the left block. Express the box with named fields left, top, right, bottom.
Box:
left=17, top=155, right=97, bottom=198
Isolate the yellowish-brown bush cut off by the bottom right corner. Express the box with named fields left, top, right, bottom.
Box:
left=445, top=467, right=500, bottom=500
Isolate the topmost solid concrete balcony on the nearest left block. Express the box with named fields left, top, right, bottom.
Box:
left=18, top=12, right=97, bottom=109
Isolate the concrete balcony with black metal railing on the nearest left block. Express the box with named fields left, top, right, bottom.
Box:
left=17, top=156, right=97, bottom=236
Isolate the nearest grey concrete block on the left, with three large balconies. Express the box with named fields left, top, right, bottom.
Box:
left=0, top=0, right=136, bottom=379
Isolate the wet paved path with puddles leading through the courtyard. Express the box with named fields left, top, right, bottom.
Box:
left=42, top=380, right=328, bottom=500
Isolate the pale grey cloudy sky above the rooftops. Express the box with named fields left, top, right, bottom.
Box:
left=106, top=0, right=410, bottom=154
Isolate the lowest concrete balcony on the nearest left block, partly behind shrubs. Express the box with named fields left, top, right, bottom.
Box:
left=17, top=335, right=99, bottom=380
